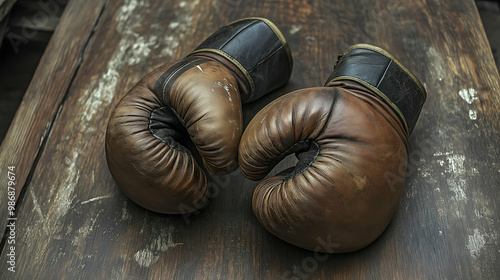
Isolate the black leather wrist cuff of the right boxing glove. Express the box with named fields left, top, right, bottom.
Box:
left=325, top=44, right=427, bottom=135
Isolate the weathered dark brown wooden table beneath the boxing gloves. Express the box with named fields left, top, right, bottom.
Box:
left=0, top=0, right=500, bottom=279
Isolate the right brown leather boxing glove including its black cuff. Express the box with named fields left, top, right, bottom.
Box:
left=239, top=45, right=427, bottom=253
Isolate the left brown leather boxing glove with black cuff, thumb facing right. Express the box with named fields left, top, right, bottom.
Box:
left=106, top=18, right=292, bottom=214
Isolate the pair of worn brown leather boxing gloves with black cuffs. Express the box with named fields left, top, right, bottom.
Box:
left=106, top=18, right=426, bottom=253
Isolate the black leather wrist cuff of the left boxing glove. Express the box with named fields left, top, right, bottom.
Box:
left=190, top=18, right=293, bottom=102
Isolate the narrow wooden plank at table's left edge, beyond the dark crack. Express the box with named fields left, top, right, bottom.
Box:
left=0, top=1, right=108, bottom=232
